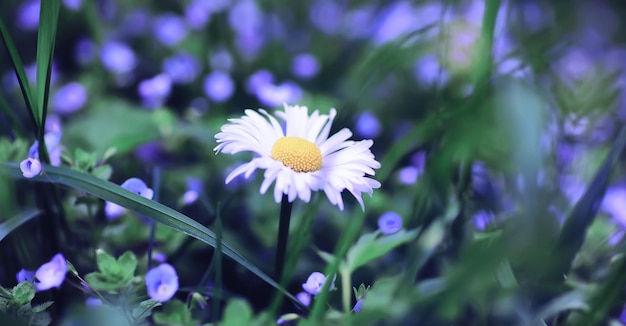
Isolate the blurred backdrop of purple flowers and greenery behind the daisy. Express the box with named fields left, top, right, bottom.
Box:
left=0, top=0, right=626, bottom=324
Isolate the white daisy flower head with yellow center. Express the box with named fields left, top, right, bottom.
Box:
left=214, top=104, right=380, bottom=210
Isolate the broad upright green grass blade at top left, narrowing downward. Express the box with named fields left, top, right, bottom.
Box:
left=34, top=0, right=61, bottom=132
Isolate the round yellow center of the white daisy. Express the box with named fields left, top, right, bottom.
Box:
left=272, top=137, right=322, bottom=172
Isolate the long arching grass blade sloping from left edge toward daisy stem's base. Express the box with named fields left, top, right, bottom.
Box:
left=0, top=163, right=301, bottom=306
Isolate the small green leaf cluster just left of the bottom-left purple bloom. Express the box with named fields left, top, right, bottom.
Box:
left=85, top=249, right=137, bottom=292
